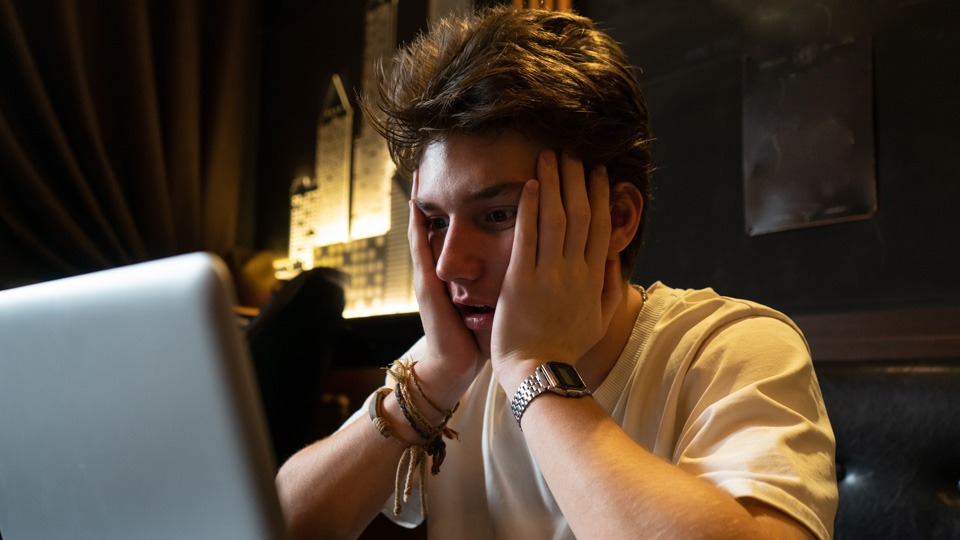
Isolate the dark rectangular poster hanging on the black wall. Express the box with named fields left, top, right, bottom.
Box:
left=743, top=38, right=877, bottom=236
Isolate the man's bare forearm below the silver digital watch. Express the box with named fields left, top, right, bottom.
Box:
left=523, top=394, right=809, bottom=539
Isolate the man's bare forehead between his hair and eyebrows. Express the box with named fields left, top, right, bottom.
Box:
left=416, top=132, right=543, bottom=203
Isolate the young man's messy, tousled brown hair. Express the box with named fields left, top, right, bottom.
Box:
left=361, top=7, right=651, bottom=277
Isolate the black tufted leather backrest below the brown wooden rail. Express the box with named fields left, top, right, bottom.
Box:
left=817, top=360, right=960, bottom=540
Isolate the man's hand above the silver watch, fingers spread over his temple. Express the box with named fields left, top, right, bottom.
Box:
left=490, top=150, right=613, bottom=381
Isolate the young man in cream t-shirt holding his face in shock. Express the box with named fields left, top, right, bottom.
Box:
left=277, top=5, right=837, bottom=540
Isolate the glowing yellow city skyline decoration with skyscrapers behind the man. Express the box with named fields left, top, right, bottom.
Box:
left=274, top=6, right=417, bottom=318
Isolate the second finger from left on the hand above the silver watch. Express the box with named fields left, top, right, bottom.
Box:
left=537, top=150, right=567, bottom=266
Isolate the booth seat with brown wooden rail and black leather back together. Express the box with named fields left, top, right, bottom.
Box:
left=794, top=306, right=960, bottom=540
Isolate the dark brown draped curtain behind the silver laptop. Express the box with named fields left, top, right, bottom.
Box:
left=0, top=0, right=259, bottom=282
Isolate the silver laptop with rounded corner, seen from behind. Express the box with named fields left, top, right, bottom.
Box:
left=0, top=253, right=285, bottom=540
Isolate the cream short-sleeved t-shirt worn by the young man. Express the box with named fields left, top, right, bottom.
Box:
left=357, top=283, right=837, bottom=540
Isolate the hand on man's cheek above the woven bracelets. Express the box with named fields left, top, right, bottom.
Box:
left=407, top=173, right=486, bottom=386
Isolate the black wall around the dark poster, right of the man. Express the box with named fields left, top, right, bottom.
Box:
left=577, top=0, right=960, bottom=313
